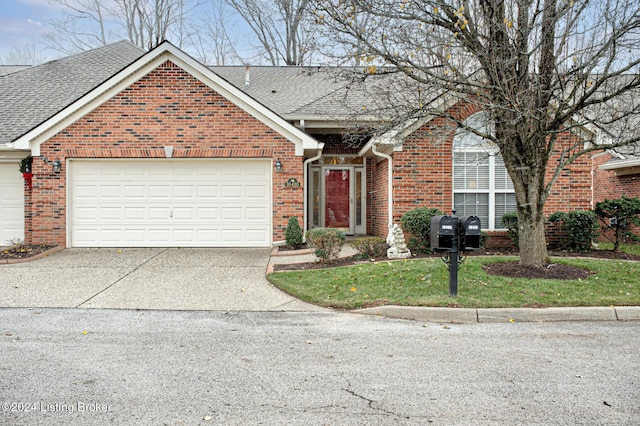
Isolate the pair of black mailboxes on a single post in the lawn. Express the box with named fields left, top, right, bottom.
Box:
left=431, top=209, right=481, bottom=297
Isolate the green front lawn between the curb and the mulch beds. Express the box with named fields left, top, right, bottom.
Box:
left=268, top=257, right=640, bottom=309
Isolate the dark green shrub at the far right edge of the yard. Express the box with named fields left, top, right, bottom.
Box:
left=595, top=195, right=640, bottom=251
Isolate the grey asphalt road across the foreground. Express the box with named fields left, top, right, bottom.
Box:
left=0, top=308, right=640, bottom=425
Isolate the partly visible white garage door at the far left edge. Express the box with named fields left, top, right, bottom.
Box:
left=0, top=162, right=24, bottom=246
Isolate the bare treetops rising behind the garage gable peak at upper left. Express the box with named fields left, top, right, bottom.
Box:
left=45, top=0, right=200, bottom=54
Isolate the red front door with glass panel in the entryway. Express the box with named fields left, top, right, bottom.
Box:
left=324, top=169, right=351, bottom=232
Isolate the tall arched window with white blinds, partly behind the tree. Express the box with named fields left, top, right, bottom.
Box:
left=453, top=113, right=516, bottom=230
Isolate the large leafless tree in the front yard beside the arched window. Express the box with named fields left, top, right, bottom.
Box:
left=313, top=0, right=640, bottom=267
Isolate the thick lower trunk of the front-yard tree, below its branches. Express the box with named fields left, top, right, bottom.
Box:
left=518, top=209, right=549, bottom=268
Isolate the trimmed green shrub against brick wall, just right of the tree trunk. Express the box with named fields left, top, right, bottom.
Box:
left=549, top=210, right=599, bottom=251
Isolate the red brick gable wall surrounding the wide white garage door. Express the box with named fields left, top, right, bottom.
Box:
left=26, top=61, right=303, bottom=246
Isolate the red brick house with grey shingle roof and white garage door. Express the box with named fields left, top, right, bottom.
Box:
left=0, top=42, right=616, bottom=247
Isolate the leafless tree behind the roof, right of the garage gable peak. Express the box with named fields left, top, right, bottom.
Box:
left=225, top=0, right=315, bottom=65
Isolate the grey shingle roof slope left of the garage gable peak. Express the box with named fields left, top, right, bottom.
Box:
left=0, top=41, right=145, bottom=144
